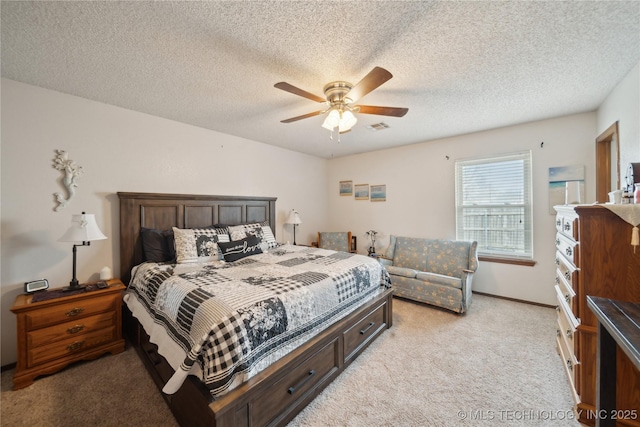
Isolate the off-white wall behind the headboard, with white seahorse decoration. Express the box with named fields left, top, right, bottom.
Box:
left=0, top=79, right=328, bottom=365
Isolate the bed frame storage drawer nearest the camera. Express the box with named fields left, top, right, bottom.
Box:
left=250, top=339, right=340, bottom=426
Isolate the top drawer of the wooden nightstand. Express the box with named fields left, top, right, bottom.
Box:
left=25, top=294, right=121, bottom=331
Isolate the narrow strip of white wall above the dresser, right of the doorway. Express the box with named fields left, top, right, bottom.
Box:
left=598, top=62, right=640, bottom=185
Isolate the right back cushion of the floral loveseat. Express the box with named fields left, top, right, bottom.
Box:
left=424, top=239, right=471, bottom=278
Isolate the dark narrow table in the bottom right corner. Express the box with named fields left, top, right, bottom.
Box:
left=587, top=296, right=640, bottom=426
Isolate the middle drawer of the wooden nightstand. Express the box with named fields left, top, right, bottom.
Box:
left=27, top=312, right=116, bottom=348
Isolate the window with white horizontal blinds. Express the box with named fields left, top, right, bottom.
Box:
left=456, top=151, right=533, bottom=260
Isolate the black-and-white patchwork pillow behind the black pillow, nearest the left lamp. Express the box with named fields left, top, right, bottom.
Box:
left=173, top=227, right=229, bottom=263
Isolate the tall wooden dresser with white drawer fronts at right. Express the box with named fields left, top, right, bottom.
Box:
left=555, top=205, right=640, bottom=427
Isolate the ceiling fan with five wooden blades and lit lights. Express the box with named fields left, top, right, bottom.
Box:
left=274, top=67, right=409, bottom=133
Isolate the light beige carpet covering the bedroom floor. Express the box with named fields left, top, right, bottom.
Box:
left=0, top=295, right=580, bottom=427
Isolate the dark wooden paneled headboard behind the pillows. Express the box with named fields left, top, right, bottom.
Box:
left=118, top=192, right=276, bottom=285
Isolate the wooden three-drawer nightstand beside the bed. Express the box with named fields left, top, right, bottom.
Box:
left=11, top=279, right=125, bottom=390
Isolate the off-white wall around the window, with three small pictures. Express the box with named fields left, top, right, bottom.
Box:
left=327, top=113, right=597, bottom=304
